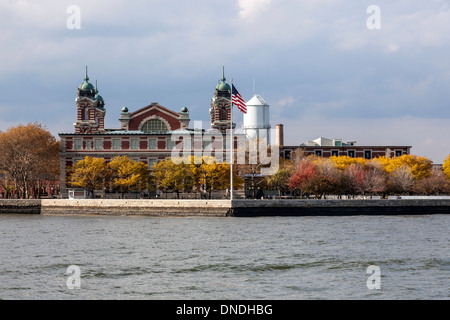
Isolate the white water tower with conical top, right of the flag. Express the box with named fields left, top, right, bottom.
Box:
left=243, top=94, right=270, bottom=143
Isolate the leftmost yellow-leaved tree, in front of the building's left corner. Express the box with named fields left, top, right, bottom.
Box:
left=70, top=157, right=108, bottom=197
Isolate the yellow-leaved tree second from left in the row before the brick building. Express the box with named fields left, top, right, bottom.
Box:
left=108, top=156, right=149, bottom=198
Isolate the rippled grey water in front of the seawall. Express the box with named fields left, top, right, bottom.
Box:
left=0, top=215, right=450, bottom=300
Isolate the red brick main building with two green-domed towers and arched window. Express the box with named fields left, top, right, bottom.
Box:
left=59, top=69, right=245, bottom=197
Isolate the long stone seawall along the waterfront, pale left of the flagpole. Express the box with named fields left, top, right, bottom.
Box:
left=0, top=199, right=450, bottom=217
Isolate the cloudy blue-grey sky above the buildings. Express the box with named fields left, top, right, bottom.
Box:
left=0, top=0, right=450, bottom=163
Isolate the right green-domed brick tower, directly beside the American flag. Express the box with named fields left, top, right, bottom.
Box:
left=209, top=68, right=236, bottom=133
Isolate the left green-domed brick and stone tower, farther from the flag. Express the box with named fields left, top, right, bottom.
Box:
left=74, top=67, right=106, bottom=133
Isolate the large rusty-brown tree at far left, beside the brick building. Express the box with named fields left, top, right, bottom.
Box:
left=0, top=122, right=60, bottom=198
